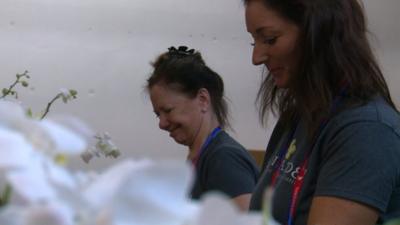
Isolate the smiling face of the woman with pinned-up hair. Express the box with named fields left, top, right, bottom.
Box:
left=150, top=84, right=204, bottom=146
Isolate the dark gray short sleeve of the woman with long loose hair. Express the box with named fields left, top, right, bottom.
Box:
left=315, top=122, right=400, bottom=212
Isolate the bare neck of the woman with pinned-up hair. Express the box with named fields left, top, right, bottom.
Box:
left=188, top=116, right=219, bottom=162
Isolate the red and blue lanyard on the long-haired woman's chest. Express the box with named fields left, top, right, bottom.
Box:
left=271, top=85, right=347, bottom=225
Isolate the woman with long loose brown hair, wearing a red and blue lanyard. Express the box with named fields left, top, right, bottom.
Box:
left=244, top=0, right=400, bottom=225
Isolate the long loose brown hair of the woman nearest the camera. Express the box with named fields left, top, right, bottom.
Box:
left=244, top=0, right=397, bottom=133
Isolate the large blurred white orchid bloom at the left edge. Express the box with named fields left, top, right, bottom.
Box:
left=0, top=100, right=86, bottom=218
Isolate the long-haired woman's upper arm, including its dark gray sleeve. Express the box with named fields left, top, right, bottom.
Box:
left=308, top=119, right=400, bottom=225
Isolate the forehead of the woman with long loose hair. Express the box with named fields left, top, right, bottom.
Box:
left=245, top=0, right=294, bottom=34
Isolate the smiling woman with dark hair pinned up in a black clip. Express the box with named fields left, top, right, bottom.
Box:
left=147, top=46, right=258, bottom=210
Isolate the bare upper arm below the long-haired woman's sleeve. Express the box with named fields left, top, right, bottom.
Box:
left=307, top=197, right=378, bottom=225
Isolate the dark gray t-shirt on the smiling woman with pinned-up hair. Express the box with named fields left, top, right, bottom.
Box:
left=191, top=131, right=259, bottom=199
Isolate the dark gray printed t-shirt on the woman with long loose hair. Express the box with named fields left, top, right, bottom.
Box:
left=250, top=98, right=400, bottom=225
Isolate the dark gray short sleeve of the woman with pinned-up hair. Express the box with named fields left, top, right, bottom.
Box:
left=206, top=147, right=258, bottom=198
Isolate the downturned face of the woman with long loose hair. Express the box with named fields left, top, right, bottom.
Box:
left=246, top=0, right=300, bottom=88
